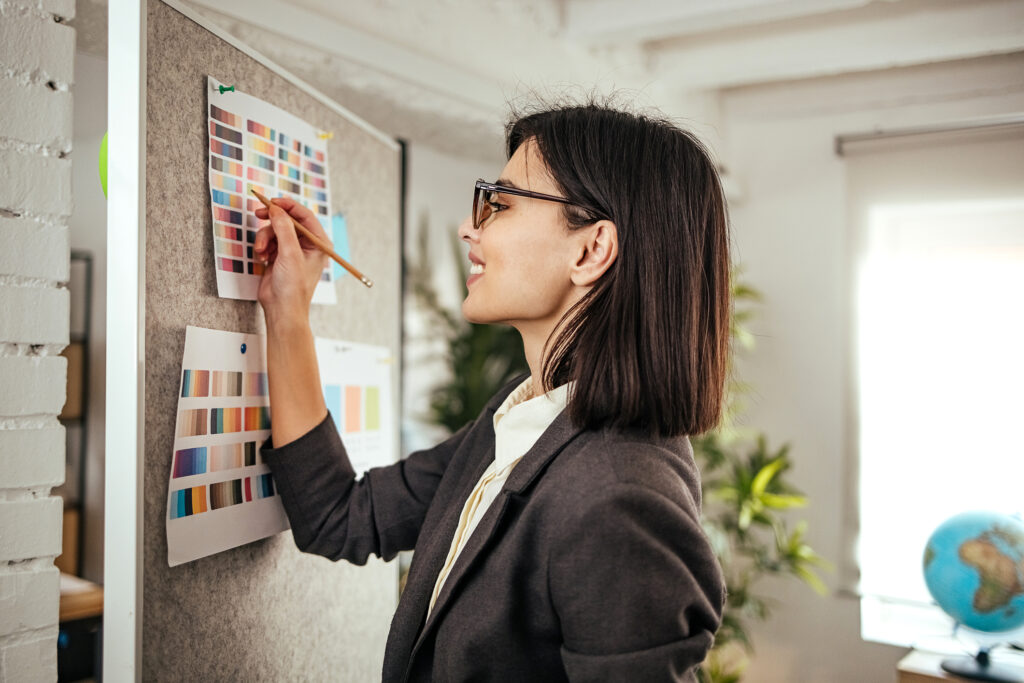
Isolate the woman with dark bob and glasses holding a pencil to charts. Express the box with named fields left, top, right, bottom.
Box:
left=256, top=105, right=729, bottom=681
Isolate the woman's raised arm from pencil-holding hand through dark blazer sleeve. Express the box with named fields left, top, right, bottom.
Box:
left=255, top=199, right=477, bottom=564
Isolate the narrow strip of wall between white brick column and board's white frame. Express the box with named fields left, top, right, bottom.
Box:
left=68, top=52, right=106, bottom=584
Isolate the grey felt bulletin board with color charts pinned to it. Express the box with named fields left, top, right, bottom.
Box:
left=141, top=0, right=401, bottom=681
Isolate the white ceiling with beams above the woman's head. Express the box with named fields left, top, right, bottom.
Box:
left=75, top=0, right=1024, bottom=158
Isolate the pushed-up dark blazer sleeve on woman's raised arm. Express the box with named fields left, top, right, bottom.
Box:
left=261, top=414, right=469, bottom=564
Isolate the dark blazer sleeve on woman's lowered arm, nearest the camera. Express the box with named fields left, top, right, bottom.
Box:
left=548, top=482, right=725, bottom=681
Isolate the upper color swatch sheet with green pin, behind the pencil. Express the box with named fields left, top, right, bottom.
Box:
left=207, top=76, right=337, bottom=304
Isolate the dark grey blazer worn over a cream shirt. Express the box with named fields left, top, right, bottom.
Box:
left=262, top=382, right=725, bottom=683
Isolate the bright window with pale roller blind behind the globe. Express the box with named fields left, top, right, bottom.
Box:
left=848, top=126, right=1024, bottom=645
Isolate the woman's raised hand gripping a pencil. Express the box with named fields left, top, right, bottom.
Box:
left=254, top=197, right=331, bottom=326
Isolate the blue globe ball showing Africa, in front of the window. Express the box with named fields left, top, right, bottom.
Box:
left=924, top=512, right=1024, bottom=633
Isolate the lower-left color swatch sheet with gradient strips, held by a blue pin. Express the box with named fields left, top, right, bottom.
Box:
left=167, top=326, right=288, bottom=566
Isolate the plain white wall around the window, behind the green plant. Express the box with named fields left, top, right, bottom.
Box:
left=722, top=55, right=1024, bottom=683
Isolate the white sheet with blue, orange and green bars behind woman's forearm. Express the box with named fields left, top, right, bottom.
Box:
left=316, top=338, right=397, bottom=475
